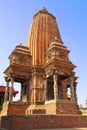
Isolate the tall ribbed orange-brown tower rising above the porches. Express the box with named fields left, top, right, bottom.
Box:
left=26, top=8, right=62, bottom=66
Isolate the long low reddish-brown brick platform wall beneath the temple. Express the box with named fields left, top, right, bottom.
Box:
left=1, top=115, right=87, bottom=130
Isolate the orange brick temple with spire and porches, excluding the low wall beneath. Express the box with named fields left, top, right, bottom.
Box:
left=2, top=8, right=81, bottom=115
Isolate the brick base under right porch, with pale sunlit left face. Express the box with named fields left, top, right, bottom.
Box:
left=45, top=100, right=82, bottom=115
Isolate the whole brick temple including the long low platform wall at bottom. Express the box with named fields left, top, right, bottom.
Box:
left=0, top=8, right=87, bottom=130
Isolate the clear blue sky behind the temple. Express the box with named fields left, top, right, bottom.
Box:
left=0, top=0, right=87, bottom=106
